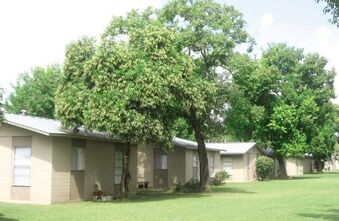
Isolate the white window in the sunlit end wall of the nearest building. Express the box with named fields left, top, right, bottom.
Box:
left=13, top=147, right=31, bottom=186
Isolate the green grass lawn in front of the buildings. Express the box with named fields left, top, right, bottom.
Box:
left=0, top=172, right=339, bottom=221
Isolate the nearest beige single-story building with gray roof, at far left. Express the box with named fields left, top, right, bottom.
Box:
left=0, top=114, right=137, bottom=204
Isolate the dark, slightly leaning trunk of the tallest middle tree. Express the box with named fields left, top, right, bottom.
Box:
left=190, top=113, right=210, bottom=192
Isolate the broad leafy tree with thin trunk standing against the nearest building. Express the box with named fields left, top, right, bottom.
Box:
left=57, top=10, right=199, bottom=197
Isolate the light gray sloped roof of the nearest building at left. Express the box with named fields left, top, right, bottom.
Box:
left=4, top=113, right=118, bottom=140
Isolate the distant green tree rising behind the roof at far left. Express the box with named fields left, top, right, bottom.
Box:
left=5, top=65, right=61, bottom=118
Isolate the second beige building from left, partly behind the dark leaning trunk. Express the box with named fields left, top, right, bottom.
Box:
left=137, top=137, right=220, bottom=188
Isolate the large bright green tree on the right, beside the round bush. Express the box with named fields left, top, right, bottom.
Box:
left=226, top=44, right=335, bottom=177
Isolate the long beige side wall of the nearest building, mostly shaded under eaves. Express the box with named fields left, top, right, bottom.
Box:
left=52, top=138, right=137, bottom=202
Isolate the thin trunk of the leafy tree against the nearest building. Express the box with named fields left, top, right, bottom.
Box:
left=120, top=142, right=131, bottom=198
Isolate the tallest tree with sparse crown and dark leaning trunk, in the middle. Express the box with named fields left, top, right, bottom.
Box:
left=159, top=0, right=251, bottom=189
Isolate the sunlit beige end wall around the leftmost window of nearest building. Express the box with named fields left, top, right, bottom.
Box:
left=0, top=124, right=52, bottom=204
